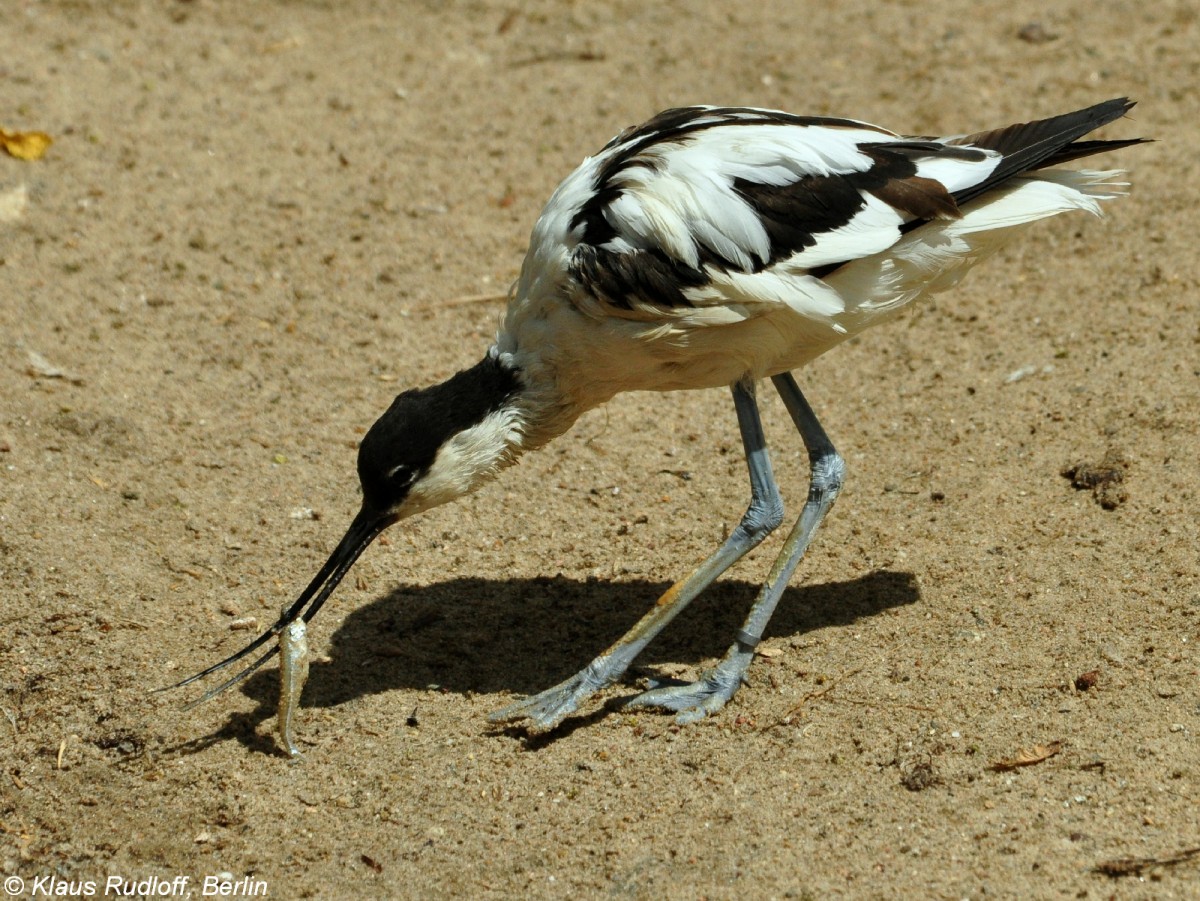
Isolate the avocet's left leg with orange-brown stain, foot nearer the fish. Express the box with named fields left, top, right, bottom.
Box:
left=490, top=379, right=784, bottom=732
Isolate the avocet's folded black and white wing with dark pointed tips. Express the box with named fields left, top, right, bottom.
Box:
left=535, top=100, right=1134, bottom=324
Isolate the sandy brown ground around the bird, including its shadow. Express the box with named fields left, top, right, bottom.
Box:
left=0, top=0, right=1200, bottom=899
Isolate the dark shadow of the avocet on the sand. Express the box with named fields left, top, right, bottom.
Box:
left=174, top=570, right=920, bottom=750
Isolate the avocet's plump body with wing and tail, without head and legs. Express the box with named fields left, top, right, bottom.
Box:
left=499, top=100, right=1138, bottom=424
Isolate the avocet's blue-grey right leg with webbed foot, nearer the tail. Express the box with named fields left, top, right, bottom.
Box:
left=630, top=373, right=846, bottom=722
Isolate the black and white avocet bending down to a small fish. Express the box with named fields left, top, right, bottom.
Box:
left=179, top=98, right=1141, bottom=732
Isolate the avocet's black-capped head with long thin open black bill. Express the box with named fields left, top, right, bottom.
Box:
left=170, top=349, right=522, bottom=704
